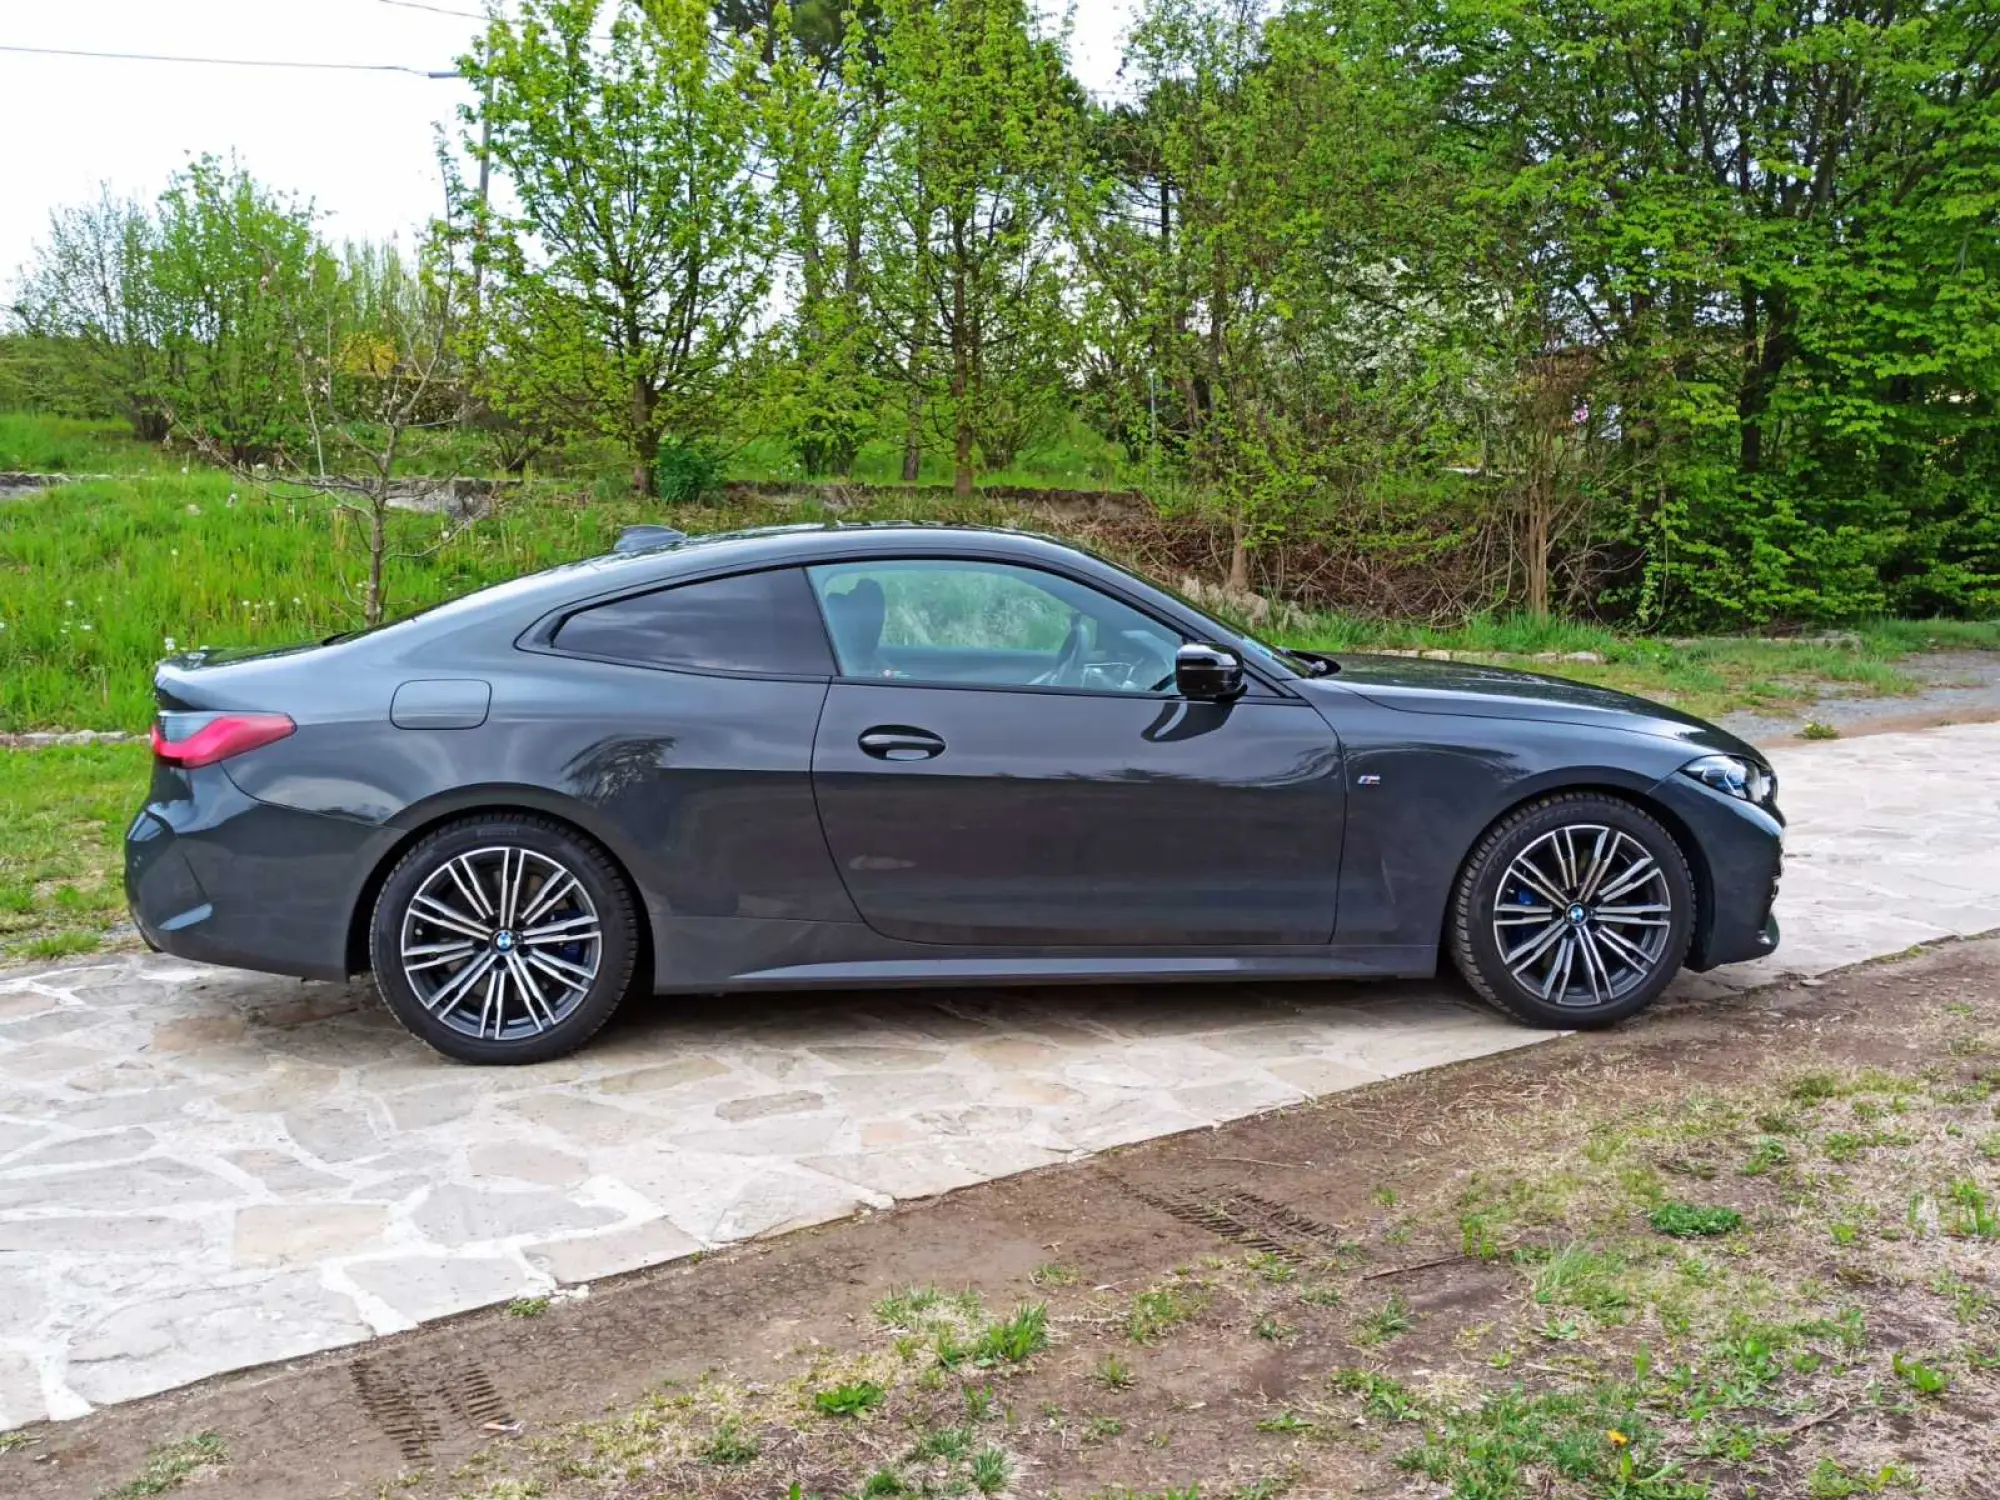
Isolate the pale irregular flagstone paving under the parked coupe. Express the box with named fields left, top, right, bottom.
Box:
left=0, top=724, right=2000, bottom=1430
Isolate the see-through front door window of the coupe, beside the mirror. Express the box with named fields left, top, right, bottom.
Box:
left=808, top=558, right=1182, bottom=696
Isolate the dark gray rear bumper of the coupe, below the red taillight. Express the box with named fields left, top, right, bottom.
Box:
left=126, top=766, right=388, bottom=980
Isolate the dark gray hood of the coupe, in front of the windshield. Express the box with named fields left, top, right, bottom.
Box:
left=1304, top=654, right=1762, bottom=760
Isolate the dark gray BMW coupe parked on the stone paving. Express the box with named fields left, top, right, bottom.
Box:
left=126, top=526, right=1782, bottom=1062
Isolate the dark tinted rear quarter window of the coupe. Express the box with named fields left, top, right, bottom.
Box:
left=554, top=568, right=834, bottom=678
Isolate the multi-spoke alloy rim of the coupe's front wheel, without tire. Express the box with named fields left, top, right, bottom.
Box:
left=1494, top=824, right=1674, bottom=1008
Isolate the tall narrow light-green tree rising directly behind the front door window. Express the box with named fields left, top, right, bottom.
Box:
left=872, top=0, right=1082, bottom=496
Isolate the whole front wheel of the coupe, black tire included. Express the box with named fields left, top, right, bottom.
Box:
left=1446, top=792, right=1694, bottom=1030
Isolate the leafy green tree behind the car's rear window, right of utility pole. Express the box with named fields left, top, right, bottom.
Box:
left=458, top=0, right=770, bottom=492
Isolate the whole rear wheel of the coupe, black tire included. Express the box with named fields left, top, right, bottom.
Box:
left=368, top=812, right=640, bottom=1064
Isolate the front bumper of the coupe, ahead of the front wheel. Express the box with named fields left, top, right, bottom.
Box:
left=1652, top=772, right=1784, bottom=970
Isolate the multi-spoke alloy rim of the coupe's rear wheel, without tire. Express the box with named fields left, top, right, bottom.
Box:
left=400, top=844, right=604, bottom=1042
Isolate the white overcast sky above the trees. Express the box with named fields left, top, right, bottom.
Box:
left=0, top=0, right=1134, bottom=300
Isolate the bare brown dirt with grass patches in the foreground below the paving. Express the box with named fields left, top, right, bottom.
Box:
left=15, top=942, right=2000, bottom=1500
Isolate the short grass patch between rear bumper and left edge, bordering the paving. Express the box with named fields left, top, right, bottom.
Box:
left=0, top=744, right=152, bottom=960
